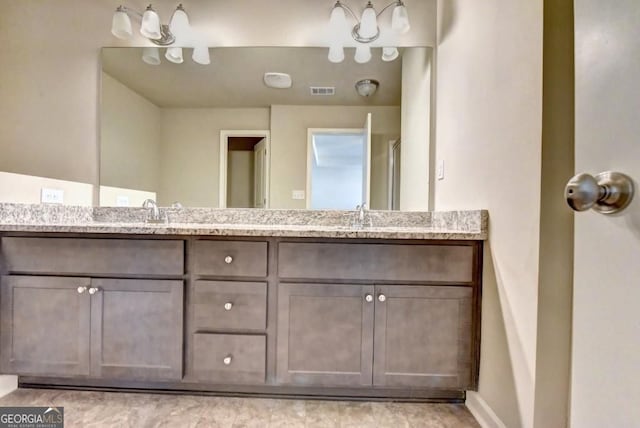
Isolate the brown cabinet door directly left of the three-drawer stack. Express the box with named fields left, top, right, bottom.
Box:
left=91, top=279, right=183, bottom=380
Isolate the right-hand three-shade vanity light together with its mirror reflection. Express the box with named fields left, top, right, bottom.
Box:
left=329, top=0, right=411, bottom=63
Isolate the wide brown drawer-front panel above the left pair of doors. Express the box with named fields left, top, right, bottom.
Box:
left=1, top=237, right=184, bottom=275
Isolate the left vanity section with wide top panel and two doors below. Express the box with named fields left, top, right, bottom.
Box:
left=0, top=237, right=184, bottom=380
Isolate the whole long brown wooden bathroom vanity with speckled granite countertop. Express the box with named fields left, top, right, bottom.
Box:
left=0, top=205, right=487, bottom=400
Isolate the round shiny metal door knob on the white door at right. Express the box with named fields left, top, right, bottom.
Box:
left=564, top=171, right=634, bottom=214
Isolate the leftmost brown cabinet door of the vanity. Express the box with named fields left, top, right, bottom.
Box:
left=0, top=276, right=90, bottom=376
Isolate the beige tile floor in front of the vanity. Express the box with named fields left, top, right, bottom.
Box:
left=0, top=389, right=479, bottom=428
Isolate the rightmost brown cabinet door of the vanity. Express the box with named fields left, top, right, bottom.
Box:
left=373, top=285, right=472, bottom=389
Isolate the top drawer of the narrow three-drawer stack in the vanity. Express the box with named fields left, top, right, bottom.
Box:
left=193, top=240, right=267, bottom=277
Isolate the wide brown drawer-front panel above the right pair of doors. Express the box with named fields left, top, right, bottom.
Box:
left=278, top=242, right=474, bottom=283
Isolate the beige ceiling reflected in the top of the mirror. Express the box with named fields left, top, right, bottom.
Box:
left=102, top=47, right=402, bottom=108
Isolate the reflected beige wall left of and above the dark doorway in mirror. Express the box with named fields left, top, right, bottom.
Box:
left=158, top=108, right=269, bottom=207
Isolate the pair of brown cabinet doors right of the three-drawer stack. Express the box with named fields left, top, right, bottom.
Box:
left=278, top=284, right=472, bottom=389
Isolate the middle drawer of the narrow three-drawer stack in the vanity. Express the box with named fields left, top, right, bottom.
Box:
left=193, top=281, right=267, bottom=330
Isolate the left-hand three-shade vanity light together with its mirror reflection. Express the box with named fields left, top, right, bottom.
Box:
left=111, top=4, right=211, bottom=65
